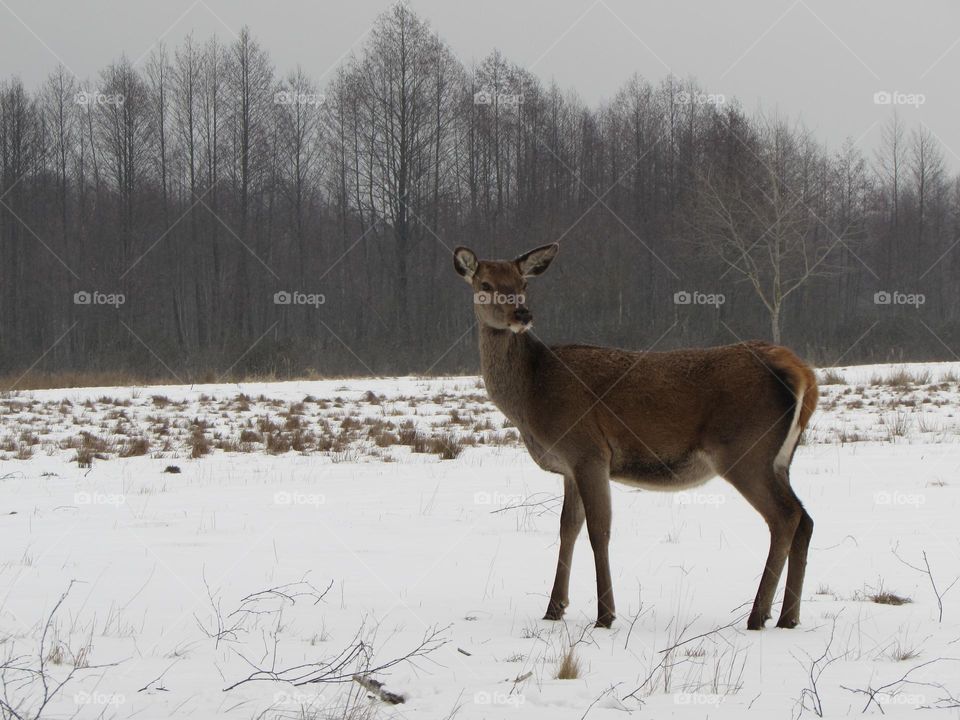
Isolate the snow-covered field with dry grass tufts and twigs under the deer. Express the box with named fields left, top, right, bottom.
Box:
left=0, top=363, right=960, bottom=720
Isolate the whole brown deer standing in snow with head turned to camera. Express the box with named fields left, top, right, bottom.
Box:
left=453, top=244, right=817, bottom=630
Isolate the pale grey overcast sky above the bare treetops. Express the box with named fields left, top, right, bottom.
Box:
left=0, top=0, right=960, bottom=168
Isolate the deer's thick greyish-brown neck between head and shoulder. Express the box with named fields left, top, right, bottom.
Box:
left=480, top=325, right=543, bottom=428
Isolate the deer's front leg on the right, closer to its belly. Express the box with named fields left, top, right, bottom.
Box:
left=574, top=460, right=617, bottom=627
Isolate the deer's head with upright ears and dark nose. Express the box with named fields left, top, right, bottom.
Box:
left=453, top=243, right=560, bottom=333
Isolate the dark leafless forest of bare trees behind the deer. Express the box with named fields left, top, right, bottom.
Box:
left=0, top=4, right=960, bottom=387
